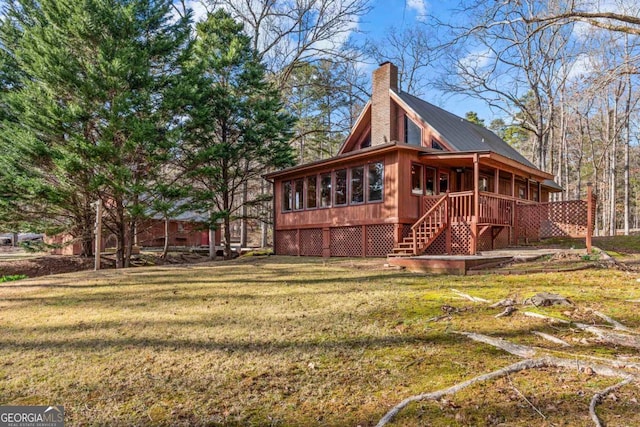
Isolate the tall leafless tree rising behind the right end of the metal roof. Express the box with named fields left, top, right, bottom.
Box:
left=439, top=2, right=574, bottom=170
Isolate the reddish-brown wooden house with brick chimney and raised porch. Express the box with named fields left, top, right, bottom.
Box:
left=266, top=62, right=586, bottom=257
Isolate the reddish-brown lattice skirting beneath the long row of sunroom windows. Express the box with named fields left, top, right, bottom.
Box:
left=275, top=224, right=396, bottom=257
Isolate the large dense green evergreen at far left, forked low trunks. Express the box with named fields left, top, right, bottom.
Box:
left=0, top=0, right=189, bottom=267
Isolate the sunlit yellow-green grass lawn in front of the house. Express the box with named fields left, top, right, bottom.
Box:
left=0, top=257, right=640, bottom=426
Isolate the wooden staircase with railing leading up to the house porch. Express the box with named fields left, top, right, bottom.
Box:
left=387, top=194, right=449, bottom=258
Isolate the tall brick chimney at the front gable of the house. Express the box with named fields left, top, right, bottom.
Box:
left=371, top=62, right=398, bottom=145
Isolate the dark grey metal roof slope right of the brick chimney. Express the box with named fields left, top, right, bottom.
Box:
left=397, top=92, right=536, bottom=171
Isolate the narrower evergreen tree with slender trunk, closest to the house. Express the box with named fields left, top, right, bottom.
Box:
left=176, top=10, right=294, bottom=257
